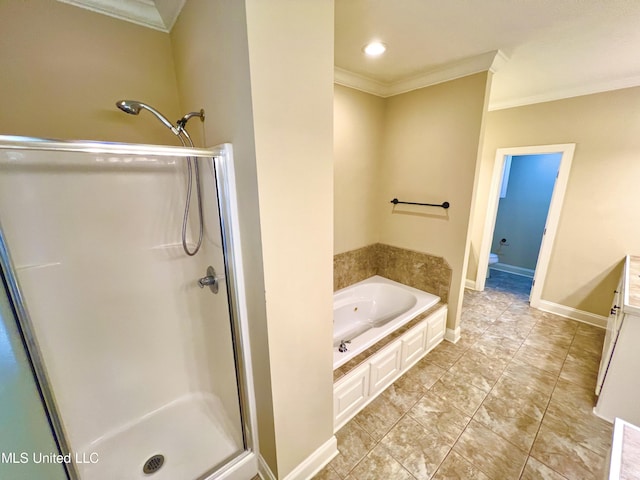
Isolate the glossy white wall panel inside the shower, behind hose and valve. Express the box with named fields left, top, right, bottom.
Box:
left=0, top=152, right=242, bottom=462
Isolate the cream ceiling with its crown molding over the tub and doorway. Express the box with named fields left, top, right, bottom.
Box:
left=335, top=0, right=640, bottom=109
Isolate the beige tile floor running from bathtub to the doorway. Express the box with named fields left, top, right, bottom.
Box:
left=314, top=272, right=612, bottom=480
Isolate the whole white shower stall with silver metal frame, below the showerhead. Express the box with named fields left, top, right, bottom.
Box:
left=0, top=136, right=257, bottom=480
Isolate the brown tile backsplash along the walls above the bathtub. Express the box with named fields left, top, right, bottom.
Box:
left=333, top=243, right=451, bottom=303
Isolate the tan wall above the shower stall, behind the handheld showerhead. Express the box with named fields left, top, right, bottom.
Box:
left=0, top=0, right=181, bottom=145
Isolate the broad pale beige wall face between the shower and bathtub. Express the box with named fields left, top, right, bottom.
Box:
left=247, top=0, right=333, bottom=478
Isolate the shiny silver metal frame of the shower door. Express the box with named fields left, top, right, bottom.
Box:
left=0, top=135, right=258, bottom=480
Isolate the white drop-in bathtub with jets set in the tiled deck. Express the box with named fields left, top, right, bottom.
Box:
left=333, top=275, right=440, bottom=370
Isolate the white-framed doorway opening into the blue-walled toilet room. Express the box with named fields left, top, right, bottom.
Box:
left=476, top=144, right=575, bottom=307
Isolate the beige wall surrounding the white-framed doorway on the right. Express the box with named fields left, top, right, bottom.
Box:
left=468, top=88, right=640, bottom=316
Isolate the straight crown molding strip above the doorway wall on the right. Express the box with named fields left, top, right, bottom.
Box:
left=488, top=76, right=640, bottom=111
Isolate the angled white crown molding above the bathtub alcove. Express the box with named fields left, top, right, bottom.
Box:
left=334, top=50, right=508, bottom=98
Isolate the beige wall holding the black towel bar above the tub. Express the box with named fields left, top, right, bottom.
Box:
left=377, top=72, right=490, bottom=329
